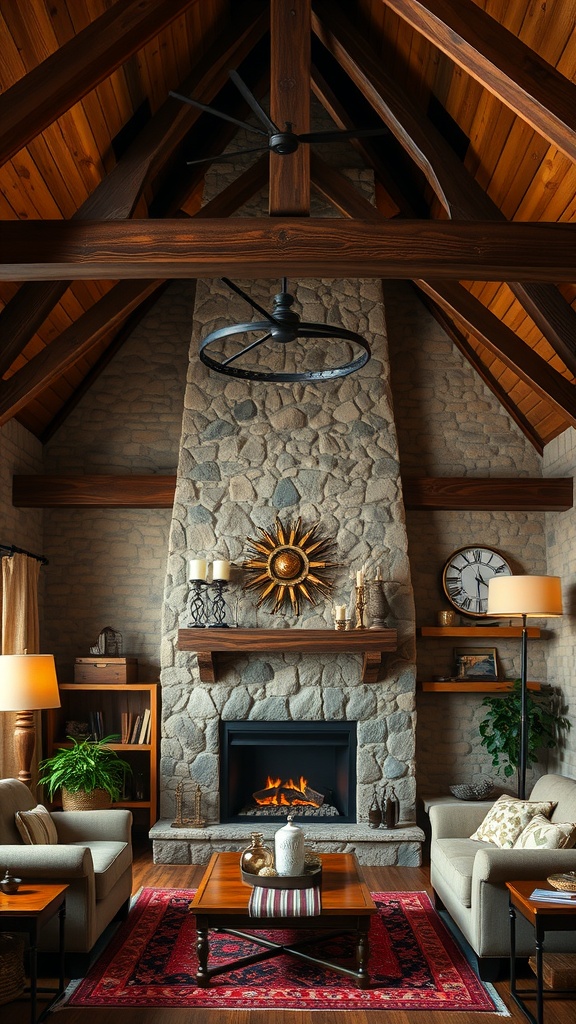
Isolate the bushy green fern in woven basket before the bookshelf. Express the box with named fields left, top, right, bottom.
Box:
left=39, top=735, right=131, bottom=811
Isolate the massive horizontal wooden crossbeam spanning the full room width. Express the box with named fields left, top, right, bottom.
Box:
left=0, top=217, right=576, bottom=282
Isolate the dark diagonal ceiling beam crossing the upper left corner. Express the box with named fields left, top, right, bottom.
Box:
left=0, top=0, right=198, bottom=165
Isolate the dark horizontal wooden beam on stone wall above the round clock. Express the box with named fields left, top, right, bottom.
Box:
left=402, top=476, right=574, bottom=512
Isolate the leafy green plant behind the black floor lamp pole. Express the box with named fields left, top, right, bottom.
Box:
left=480, top=679, right=570, bottom=794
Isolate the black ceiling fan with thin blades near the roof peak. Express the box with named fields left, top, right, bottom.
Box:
left=169, top=71, right=387, bottom=165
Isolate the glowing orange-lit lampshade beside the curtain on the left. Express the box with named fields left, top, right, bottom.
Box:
left=0, top=654, right=60, bottom=711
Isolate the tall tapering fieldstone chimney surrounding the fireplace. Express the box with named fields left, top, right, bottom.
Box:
left=152, top=167, right=420, bottom=863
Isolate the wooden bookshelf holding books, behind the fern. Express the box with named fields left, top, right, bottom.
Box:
left=44, top=683, right=159, bottom=827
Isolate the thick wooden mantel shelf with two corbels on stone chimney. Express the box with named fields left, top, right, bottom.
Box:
left=178, top=627, right=398, bottom=683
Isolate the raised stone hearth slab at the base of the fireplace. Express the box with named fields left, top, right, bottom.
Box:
left=149, top=820, right=425, bottom=867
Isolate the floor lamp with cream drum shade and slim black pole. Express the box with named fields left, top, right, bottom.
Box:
left=488, top=575, right=562, bottom=800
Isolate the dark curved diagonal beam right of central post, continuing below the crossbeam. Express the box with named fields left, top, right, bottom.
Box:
left=313, top=0, right=576, bottom=375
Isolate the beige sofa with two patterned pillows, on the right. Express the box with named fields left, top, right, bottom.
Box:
left=429, top=775, right=576, bottom=980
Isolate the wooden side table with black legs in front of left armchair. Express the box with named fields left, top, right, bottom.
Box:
left=0, top=882, right=68, bottom=1024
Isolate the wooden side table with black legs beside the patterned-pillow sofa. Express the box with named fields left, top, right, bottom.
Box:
left=506, top=881, right=576, bottom=1024
